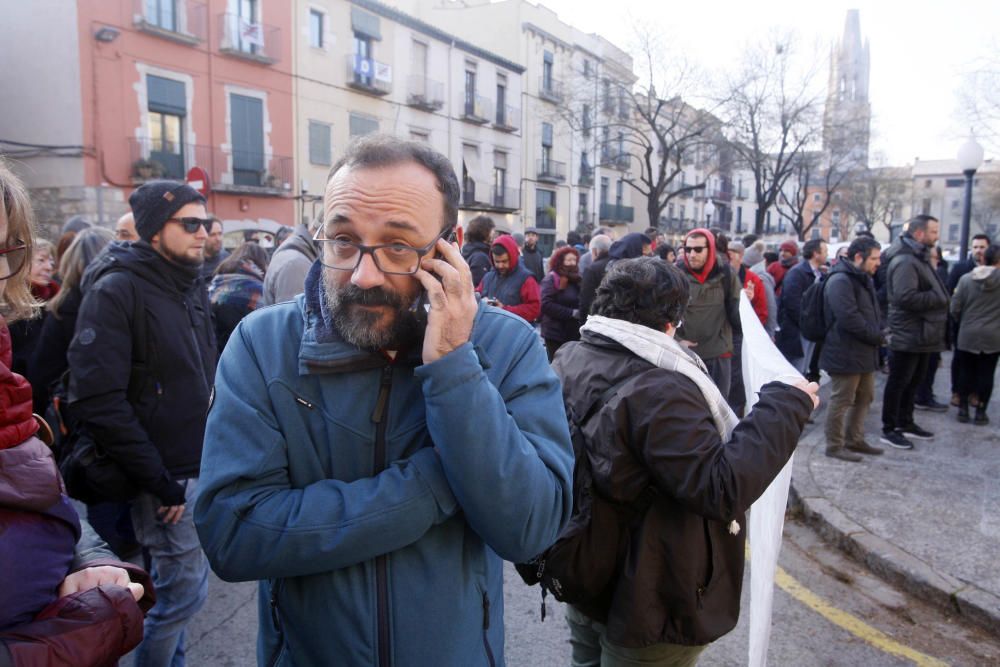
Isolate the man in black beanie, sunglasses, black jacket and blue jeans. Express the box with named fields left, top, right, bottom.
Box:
left=68, top=180, right=216, bottom=665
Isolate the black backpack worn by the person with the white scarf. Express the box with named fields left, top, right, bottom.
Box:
left=515, top=376, right=656, bottom=621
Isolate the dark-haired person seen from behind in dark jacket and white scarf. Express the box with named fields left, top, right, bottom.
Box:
left=553, top=257, right=818, bottom=665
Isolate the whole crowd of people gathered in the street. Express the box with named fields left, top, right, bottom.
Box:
left=0, top=135, right=1000, bottom=665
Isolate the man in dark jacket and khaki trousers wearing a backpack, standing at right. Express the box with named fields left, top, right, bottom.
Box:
left=819, top=237, right=885, bottom=461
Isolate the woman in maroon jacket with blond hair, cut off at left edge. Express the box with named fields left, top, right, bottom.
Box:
left=0, top=161, right=148, bottom=665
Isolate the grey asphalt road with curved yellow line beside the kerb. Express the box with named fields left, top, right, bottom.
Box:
left=166, top=519, right=1000, bottom=667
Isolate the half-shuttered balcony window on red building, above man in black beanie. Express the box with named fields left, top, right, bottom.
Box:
left=146, top=74, right=187, bottom=179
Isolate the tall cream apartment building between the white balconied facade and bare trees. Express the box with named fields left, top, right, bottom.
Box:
left=394, top=0, right=635, bottom=254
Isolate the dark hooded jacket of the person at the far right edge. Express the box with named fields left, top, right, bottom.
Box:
left=951, top=266, right=1000, bottom=354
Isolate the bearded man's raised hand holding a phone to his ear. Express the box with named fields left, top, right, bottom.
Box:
left=415, top=232, right=478, bottom=364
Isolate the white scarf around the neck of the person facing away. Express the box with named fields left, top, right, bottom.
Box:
left=580, top=315, right=739, bottom=442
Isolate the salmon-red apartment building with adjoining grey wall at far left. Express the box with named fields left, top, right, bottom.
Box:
left=0, top=0, right=295, bottom=236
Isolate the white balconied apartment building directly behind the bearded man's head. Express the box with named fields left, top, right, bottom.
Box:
left=294, top=0, right=524, bottom=230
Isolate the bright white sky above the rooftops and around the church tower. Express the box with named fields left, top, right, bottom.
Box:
left=534, top=0, right=1000, bottom=165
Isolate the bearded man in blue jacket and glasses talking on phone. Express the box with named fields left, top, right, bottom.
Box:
left=195, top=135, right=573, bottom=667
